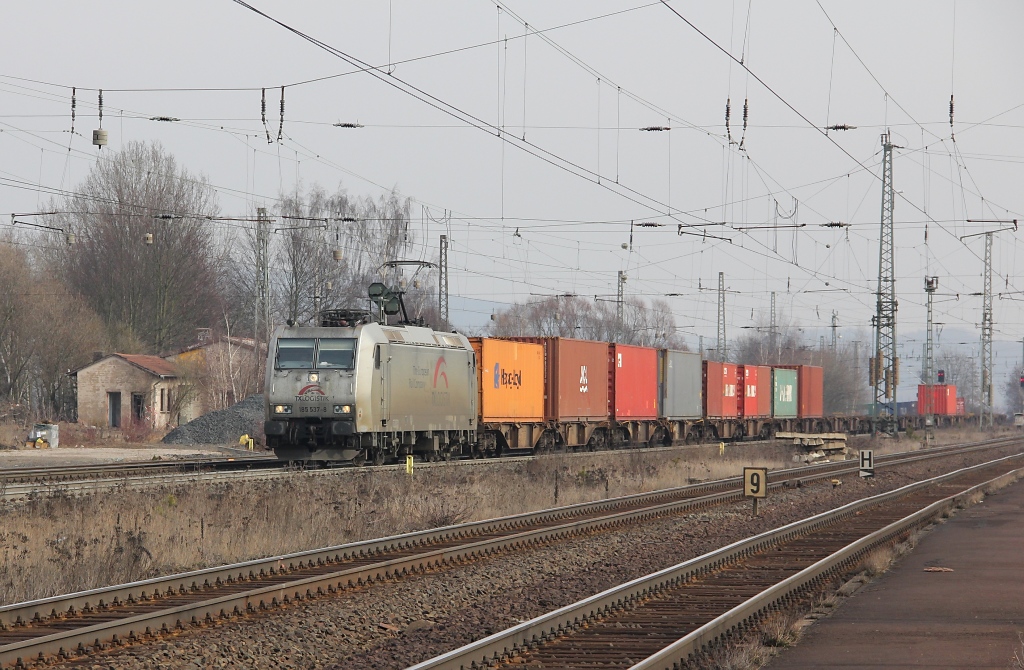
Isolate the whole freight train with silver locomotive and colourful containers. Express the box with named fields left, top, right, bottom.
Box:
left=264, top=312, right=966, bottom=464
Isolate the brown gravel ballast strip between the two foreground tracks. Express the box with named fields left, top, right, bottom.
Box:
left=46, top=449, right=1018, bottom=670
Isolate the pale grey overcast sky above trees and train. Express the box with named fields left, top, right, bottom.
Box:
left=0, top=0, right=1024, bottom=400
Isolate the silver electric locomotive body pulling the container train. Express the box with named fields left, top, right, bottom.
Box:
left=264, top=323, right=477, bottom=463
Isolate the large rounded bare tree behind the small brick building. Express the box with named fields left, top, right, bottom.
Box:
left=49, top=141, right=220, bottom=352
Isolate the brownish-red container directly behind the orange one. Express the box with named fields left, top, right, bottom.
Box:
left=509, top=337, right=608, bottom=421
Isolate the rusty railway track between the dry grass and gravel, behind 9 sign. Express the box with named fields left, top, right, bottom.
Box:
left=0, top=441, right=1009, bottom=667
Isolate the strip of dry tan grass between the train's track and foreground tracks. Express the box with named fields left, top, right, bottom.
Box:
left=0, top=452, right=786, bottom=604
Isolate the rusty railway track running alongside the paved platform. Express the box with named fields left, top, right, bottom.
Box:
left=409, top=455, right=1024, bottom=670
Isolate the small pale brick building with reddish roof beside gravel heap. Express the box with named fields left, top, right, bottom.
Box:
left=72, top=353, right=182, bottom=428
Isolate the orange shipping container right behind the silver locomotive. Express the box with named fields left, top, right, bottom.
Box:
left=469, top=337, right=544, bottom=423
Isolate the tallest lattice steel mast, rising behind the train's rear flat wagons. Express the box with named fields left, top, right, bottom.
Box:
left=870, top=131, right=899, bottom=435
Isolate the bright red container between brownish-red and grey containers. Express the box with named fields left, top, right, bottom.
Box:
left=607, top=344, right=657, bottom=419
